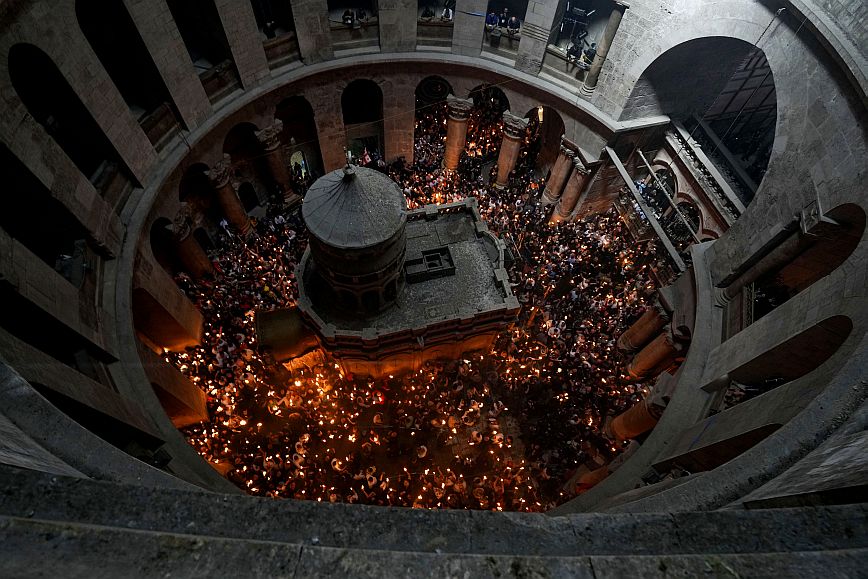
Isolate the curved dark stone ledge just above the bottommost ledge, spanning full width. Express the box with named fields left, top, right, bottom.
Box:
left=0, top=468, right=868, bottom=557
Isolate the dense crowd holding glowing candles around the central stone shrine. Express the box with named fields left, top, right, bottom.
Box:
left=166, top=94, right=656, bottom=511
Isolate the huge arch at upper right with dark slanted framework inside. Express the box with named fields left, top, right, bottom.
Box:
left=621, top=36, right=777, bottom=205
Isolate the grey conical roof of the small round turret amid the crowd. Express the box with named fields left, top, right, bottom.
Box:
left=301, top=165, right=407, bottom=249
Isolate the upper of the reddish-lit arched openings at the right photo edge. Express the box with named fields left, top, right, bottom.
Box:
left=747, top=203, right=865, bottom=321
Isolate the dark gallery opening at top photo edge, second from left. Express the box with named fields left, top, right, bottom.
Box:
left=166, top=0, right=241, bottom=103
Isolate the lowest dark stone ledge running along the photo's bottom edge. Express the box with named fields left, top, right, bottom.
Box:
left=0, top=516, right=868, bottom=579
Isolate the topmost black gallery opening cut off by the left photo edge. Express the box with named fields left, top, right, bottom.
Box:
left=0, top=145, right=89, bottom=276
